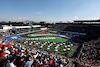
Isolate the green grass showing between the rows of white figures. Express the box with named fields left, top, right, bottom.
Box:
left=23, top=43, right=78, bottom=57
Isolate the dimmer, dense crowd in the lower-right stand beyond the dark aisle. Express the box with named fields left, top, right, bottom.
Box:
left=81, top=39, right=100, bottom=66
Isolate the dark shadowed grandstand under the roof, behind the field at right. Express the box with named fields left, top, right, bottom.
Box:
left=51, top=23, right=100, bottom=41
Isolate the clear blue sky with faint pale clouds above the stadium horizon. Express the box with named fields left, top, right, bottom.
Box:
left=0, top=0, right=100, bottom=22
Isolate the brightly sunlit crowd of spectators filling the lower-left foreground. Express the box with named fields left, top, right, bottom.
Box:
left=0, top=33, right=69, bottom=67
